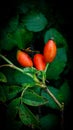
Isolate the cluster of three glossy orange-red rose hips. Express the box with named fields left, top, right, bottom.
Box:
left=17, top=39, right=57, bottom=71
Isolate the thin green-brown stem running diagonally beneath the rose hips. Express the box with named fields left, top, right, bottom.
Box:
left=0, top=54, right=64, bottom=111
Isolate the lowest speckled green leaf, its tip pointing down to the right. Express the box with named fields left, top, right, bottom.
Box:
left=19, top=104, right=39, bottom=127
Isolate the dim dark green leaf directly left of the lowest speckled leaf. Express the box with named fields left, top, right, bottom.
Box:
left=7, top=98, right=20, bottom=119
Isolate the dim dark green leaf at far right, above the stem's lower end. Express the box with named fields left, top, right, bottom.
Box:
left=58, top=81, right=71, bottom=106
